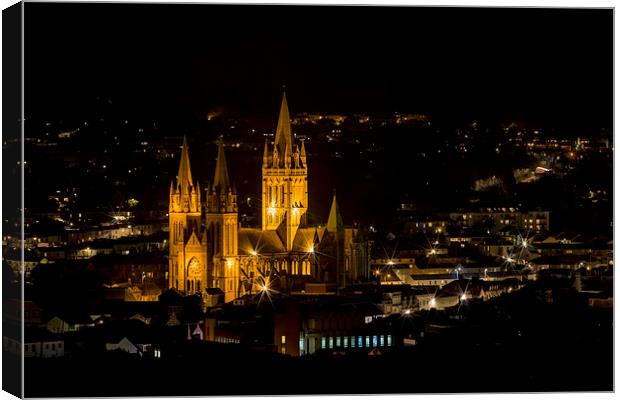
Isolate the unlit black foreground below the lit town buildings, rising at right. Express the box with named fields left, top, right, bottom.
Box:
left=25, top=296, right=613, bottom=397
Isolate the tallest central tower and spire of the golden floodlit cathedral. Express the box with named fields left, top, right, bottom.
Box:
left=262, top=94, right=308, bottom=251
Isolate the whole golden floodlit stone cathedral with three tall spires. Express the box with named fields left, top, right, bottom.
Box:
left=168, top=94, right=369, bottom=302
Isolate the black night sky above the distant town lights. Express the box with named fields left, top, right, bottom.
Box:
left=25, top=3, right=613, bottom=128
